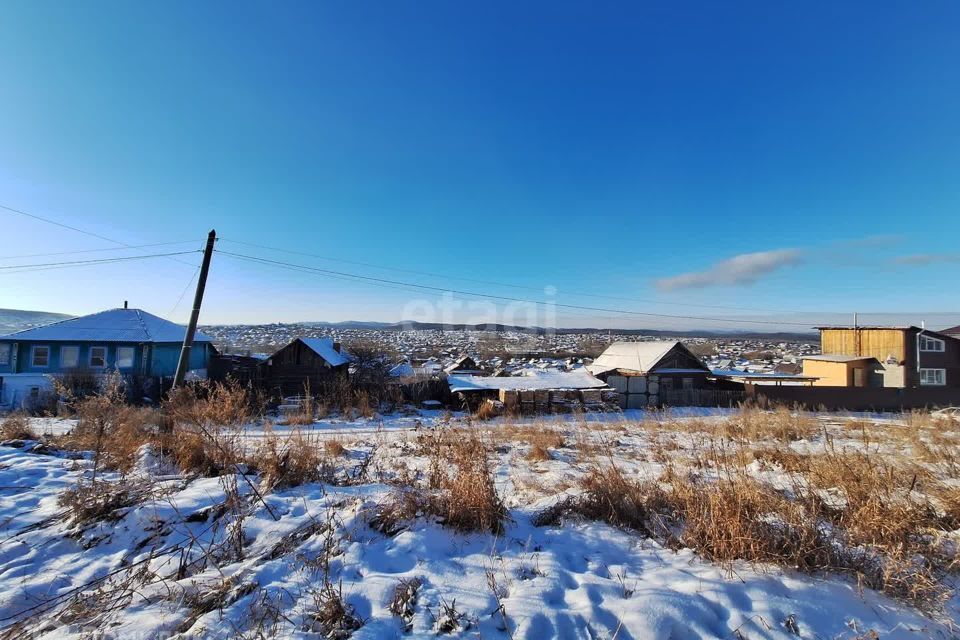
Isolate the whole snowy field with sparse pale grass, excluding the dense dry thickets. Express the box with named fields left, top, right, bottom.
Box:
left=0, top=411, right=960, bottom=640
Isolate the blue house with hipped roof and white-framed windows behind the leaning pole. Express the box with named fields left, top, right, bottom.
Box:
left=0, top=307, right=213, bottom=407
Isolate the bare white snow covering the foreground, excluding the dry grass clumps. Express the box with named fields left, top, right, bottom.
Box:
left=0, top=409, right=957, bottom=640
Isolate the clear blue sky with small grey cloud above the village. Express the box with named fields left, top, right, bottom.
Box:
left=0, top=1, right=960, bottom=328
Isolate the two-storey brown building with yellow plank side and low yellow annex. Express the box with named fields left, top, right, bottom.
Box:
left=803, top=326, right=960, bottom=388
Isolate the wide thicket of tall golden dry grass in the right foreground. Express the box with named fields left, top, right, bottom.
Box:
left=535, top=444, right=960, bottom=610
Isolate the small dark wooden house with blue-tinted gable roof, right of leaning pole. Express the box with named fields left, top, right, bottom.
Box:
left=260, top=338, right=350, bottom=397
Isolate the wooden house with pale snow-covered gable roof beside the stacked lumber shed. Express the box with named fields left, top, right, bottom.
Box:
left=587, top=341, right=712, bottom=409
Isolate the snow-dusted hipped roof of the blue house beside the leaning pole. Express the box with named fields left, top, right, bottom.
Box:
left=0, top=309, right=213, bottom=343
